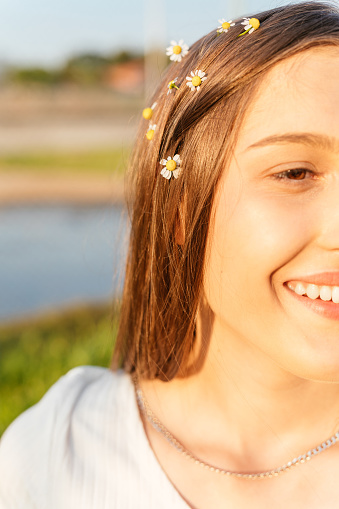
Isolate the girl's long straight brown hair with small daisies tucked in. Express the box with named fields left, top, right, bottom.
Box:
left=112, top=2, right=339, bottom=380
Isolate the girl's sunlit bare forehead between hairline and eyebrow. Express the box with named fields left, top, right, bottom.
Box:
left=237, top=47, right=339, bottom=151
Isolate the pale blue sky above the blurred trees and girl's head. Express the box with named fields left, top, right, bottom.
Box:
left=0, top=0, right=292, bottom=67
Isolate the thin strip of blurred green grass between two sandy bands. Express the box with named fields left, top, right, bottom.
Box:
left=0, top=147, right=130, bottom=176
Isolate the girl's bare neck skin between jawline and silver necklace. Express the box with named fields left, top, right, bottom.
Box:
left=143, top=308, right=339, bottom=471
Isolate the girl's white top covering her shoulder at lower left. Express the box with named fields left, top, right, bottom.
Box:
left=0, top=366, right=188, bottom=509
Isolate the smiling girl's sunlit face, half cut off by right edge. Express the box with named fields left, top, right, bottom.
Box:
left=204, top=47, right=339, bottom=381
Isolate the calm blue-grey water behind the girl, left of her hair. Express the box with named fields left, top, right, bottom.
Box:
left=0, top=206, right=128, bottom=321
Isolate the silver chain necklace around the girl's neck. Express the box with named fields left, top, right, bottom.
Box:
left=133, top=377, right=339, bottom=480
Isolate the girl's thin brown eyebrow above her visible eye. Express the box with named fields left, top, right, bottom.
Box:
left=246, top=133, right=339, bottom=152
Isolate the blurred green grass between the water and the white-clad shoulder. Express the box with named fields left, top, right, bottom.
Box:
left=0, top=305, right=119, bottom=435
